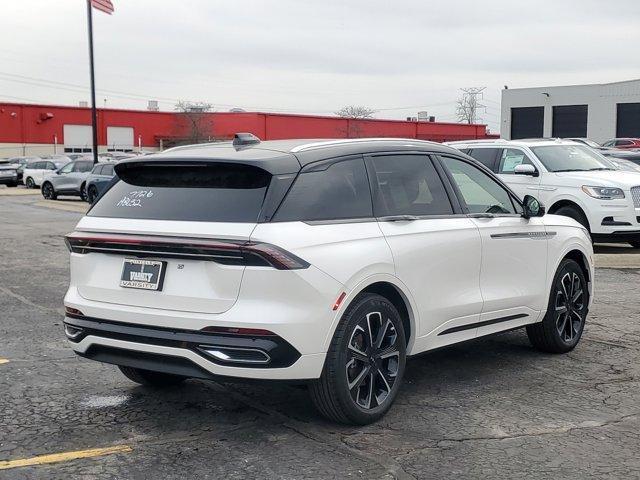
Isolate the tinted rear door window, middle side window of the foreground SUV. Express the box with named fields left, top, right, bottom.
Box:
left=369, top=155, right=453, bottom=216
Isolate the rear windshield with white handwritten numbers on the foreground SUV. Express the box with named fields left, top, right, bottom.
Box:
left=88, top=163, right=271, bottom=222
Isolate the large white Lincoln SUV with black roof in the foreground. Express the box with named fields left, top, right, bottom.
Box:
left=64, top=134, right=594, bottom=424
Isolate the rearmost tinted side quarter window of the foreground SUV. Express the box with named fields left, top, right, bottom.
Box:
left=274, top=158, right=373, bottom=222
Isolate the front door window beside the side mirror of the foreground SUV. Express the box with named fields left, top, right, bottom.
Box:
left=442, top=157, right=516, bottom=214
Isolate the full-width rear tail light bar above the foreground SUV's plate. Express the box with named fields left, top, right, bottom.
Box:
left=65, top=232, right=309, bottom=270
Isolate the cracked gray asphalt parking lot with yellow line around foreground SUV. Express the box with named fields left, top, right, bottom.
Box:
left=0, top=189, right=640, bottom=479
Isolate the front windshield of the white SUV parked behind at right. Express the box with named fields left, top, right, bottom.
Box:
left=531, top=145, right=614, bottom=172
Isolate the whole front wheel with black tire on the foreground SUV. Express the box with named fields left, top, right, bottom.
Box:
left=527, top=258, right=589, bottom=353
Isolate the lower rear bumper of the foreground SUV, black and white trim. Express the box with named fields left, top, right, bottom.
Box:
left=64, top=316, right=325, bottom=380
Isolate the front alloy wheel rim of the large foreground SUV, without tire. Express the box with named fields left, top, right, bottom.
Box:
left=555, top=272, right=585, bottom=343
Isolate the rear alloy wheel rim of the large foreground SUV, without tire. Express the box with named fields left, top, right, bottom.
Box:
left=345, top=312, right=400, bottom=410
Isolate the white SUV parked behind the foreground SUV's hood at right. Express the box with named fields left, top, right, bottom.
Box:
left=448, top=139, right=640, bottom=248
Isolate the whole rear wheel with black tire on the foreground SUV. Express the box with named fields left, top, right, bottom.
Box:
left=309, top=293, right=406, bottom=425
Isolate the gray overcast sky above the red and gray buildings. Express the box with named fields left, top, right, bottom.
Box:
left=0, top=0, right=640, bottom=131
